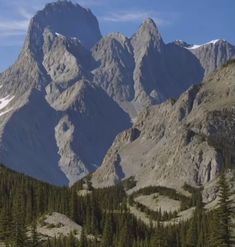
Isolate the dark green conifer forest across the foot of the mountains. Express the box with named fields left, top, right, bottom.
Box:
left=0, top=163, right=234, bottom=247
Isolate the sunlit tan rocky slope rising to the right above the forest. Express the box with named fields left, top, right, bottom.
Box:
left=92, top=62, right=235, bottom=189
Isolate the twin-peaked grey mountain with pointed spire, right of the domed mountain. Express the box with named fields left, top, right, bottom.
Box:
left=92, top=19, right=206, bottom=118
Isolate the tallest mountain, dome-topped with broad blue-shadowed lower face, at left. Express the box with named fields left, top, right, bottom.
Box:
left=0, top=1, right=130, bottom=184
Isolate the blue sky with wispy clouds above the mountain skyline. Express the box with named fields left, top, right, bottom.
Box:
left=0, top=0, right=235, bottom=72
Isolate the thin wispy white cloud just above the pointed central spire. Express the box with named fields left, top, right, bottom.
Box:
left=100, top=10, right=175, bottom=26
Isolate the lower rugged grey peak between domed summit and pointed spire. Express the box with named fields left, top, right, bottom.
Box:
left=92, top=33, right=135, bottom=103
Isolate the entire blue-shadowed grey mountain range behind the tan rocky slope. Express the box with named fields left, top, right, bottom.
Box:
left=0, top=1, right=234, bottom=184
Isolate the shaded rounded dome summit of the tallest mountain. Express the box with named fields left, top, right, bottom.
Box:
left=25, top=1, right=101, bottom=48
